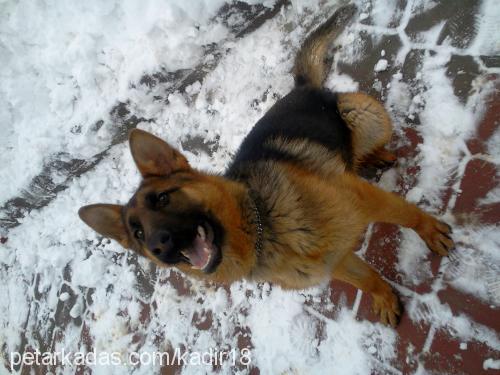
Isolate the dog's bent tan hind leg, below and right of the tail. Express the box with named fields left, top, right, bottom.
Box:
left=337, top=93, right=396, bottom=168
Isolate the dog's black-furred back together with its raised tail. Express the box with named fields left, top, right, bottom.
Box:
left=226, top=5, right=356, bottom=179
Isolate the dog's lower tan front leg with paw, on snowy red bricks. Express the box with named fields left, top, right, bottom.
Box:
left=332, top=252, right=401, bottom=327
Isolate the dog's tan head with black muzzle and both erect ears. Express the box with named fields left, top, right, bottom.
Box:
left=79, top=129, right=254, bottom=279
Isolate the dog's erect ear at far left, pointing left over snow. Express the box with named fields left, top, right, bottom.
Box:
left=78, top=204, right=128, bottom=247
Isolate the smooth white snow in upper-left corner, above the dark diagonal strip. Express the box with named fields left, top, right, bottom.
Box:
left=0, top=0, right=227, bottom=206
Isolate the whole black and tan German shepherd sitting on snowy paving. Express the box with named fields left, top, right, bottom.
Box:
left=79, top=5, right=454, bottom=326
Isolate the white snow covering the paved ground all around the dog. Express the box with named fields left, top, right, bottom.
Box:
left=0, top=0, right=500, bottom=374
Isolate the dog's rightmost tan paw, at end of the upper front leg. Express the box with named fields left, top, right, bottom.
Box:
left=416, top=215, right=455, bottom=256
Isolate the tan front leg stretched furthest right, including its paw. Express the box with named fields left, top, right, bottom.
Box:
left=342, top=174, right=454, bottom=256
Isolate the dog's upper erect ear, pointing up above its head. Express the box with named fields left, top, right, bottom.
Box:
left=129, top=129, right=190, bottom=177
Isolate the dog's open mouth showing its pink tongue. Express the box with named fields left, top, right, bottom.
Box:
left=181, top=222, right=219, bottom=273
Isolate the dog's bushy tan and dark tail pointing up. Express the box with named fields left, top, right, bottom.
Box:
left=293, top=4, right=357, bottom=87
